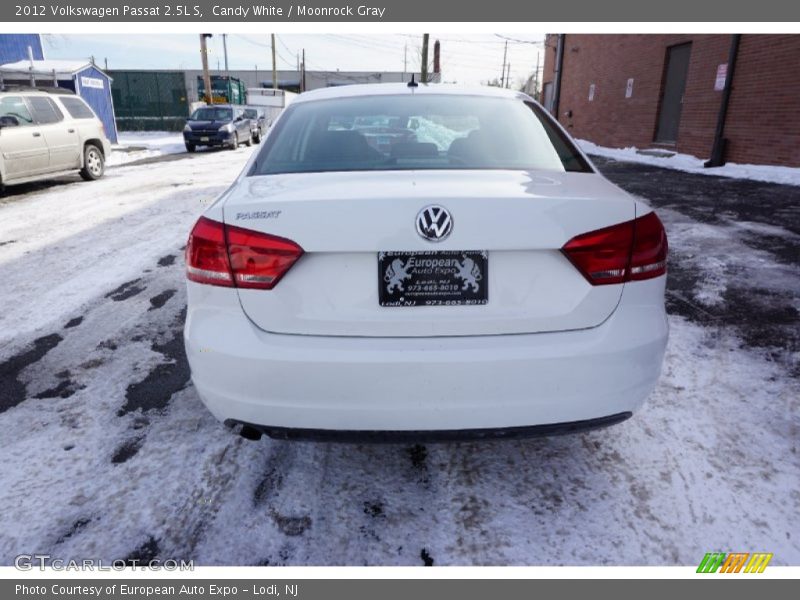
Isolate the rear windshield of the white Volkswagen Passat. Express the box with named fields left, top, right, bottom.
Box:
left=250, top=94, right=591, bottom=175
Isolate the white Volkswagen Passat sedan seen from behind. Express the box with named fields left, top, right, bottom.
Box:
left=185, top=84, right=668, bottom=441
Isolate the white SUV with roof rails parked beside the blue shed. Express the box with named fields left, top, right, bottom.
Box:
left=0, top=88, right=111, bottom=185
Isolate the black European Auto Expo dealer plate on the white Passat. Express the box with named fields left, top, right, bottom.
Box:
left=377, top=250, right=489, bottom=308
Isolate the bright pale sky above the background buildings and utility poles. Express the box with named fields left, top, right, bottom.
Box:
left=42, top=33, right=544, bottom=87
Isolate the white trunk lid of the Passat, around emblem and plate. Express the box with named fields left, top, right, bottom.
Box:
left=224, top=170, right=635, bottom=337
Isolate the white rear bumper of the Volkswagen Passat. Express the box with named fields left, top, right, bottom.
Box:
left=184, top=277, right=668, bottom=439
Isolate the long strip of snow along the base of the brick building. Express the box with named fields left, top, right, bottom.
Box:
left=577, top=140, right=800, bottom=186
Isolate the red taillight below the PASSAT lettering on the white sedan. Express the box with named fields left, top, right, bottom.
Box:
left=186, top=217, right=303, bottom=290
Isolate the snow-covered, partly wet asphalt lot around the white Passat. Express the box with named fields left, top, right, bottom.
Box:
left=0, top=148, right=800, bottom=565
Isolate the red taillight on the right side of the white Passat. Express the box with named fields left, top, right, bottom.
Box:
left=562, top=212, right=667, bottom=285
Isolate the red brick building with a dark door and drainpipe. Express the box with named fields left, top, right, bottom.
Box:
left=542, top=34, right=800, bottom=167
